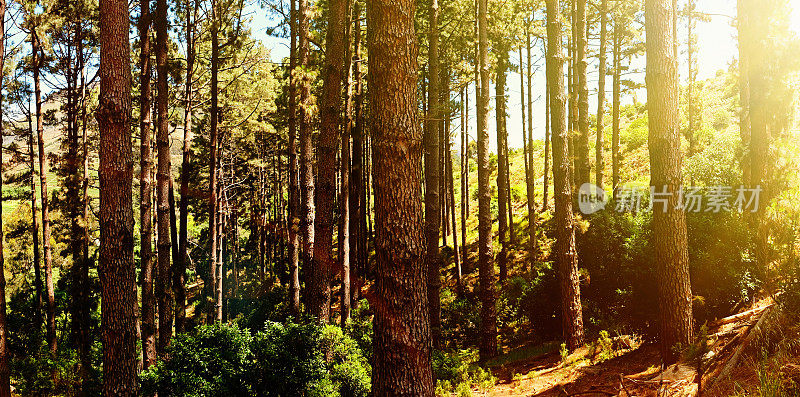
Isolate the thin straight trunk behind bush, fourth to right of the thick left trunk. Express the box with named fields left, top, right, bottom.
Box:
left=206, top=0, right=222, bottom=323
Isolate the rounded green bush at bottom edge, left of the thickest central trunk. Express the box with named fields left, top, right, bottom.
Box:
left=142, top=321, right=370, bottom=397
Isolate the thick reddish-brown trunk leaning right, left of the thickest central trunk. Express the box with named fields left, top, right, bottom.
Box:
left=310, top=0, right=349, bottom=323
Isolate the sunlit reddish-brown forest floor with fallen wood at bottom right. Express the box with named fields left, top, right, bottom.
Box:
left=473, top=299, right=800, bottom=397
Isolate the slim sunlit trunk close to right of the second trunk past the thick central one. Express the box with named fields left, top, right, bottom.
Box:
left=495, top=51, right=508, bottom=283
